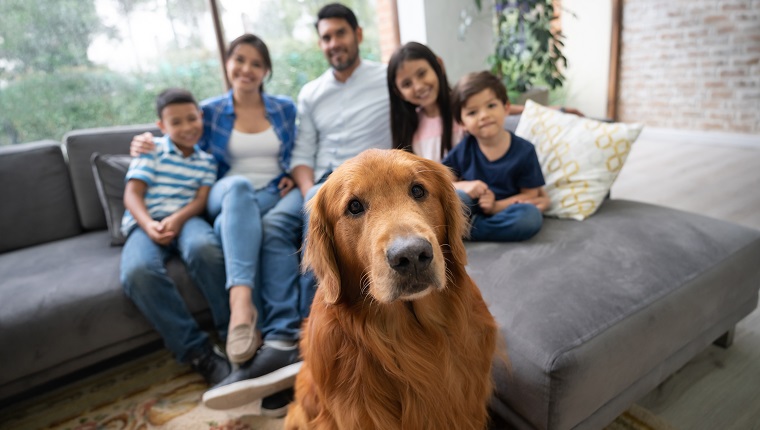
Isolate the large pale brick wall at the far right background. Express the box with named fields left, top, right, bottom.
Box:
left=618, top=0, right=760, bottom=134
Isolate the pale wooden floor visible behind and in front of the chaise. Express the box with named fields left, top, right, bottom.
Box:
left=611, top=135, right=760, bottom=430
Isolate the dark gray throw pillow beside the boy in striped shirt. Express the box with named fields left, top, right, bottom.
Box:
left=90, top=152, right=132, bottom=246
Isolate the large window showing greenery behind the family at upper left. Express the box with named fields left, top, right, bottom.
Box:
left=0, top=0, right=380, bottom=145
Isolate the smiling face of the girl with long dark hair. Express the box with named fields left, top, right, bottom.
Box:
left=396, top=60, right=440, bottom=115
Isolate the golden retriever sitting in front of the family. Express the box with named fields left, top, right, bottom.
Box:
left=285, top=150, right=497, bottom=430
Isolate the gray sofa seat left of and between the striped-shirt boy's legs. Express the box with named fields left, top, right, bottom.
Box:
left=0, top=230, right=207, bottom=387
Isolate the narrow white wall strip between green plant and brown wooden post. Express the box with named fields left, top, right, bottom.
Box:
left=562, top=0, right=612, bottom=118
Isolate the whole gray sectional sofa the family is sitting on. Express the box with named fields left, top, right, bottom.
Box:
left=0, top=122, right=760, bottom=429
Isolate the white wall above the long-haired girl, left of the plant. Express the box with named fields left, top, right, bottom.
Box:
left=397, top=0, right=493, bottom=85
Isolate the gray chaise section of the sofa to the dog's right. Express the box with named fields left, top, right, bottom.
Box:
left=467, top=200, right=760, bottom=429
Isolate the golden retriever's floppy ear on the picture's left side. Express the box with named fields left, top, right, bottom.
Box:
left=303, top=186, right=340, bottom=304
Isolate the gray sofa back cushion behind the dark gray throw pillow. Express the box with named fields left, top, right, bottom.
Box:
left=63, top=124, right=160, bottom=230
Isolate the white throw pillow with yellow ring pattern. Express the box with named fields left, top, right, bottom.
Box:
left=515, top=100, right=644, bottom=220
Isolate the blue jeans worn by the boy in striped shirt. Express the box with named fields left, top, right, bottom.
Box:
left=121, top=217, right=230, bottom=362
